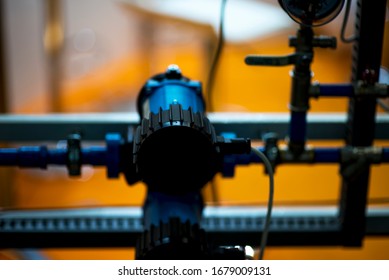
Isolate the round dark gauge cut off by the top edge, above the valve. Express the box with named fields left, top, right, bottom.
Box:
left=279, top=0, right=344, bottom=26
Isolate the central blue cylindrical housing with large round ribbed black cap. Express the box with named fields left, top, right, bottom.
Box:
left=135, top=65, right=214, bottom=228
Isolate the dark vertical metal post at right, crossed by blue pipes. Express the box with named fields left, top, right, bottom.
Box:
left=339, top=0, right=386, bottom=246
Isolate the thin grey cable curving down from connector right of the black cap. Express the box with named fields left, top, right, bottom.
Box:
left=251, top=148, right=274, bottom=260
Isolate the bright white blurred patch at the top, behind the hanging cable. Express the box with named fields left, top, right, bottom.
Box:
left=120, top=0, right=291, bottom=42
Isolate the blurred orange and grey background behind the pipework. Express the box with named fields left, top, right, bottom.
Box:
left=0, top=0, right=389, bottom=259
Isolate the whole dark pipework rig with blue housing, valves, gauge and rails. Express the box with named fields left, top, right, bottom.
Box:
left=0, top=0, right=389, bottom=259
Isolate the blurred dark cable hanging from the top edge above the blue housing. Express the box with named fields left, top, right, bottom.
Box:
left=207, top=0, right=227, bottom=112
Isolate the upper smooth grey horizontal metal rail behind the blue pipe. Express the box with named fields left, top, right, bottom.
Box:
left=0, top=113, right=389, bottom=142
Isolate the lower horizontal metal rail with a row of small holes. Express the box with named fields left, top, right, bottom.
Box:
left=0, top=206, right=389, bottom=248
